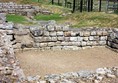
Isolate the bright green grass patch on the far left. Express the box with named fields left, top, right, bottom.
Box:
left=6, top=14, right=26, bottom=23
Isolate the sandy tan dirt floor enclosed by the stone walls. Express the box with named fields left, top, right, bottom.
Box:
left=16, top=47, right=118, bottom=76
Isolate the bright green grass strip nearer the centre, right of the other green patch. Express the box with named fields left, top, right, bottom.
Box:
left=34, top=14, right=62, bottom=21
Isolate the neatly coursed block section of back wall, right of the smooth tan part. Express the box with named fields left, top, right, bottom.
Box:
left=30, top=25, right=108, bottom=50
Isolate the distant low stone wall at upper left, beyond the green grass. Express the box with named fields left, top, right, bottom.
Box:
left=0, top=2, right=51, bottom=17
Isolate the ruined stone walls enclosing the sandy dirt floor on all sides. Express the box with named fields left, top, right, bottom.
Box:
left=0, top=17, right=118, bottom=83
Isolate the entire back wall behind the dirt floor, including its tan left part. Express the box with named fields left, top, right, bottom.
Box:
left=9, top=23, right=117, bottom=50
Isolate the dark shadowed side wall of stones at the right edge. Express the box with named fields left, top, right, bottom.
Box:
left=107, top=29, right=118, bottom=51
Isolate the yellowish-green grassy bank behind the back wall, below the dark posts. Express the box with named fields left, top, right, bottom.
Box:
left=65, top=12, right=118, bottom=27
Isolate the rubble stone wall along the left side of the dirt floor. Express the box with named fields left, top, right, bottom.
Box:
left=0, top=30, right=25, bottom=83
